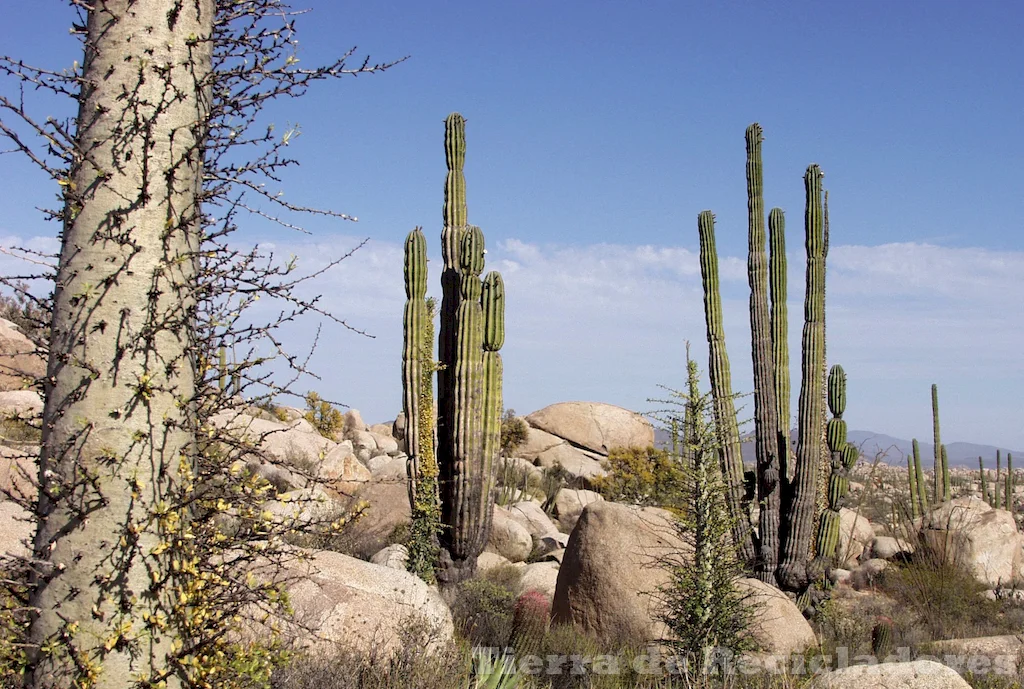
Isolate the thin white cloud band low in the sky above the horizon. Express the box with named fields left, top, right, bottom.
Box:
left=0, top=228, right=1024, bottom=449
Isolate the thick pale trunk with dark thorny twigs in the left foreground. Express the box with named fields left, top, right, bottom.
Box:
left=31, top=0, right=215, bottom=689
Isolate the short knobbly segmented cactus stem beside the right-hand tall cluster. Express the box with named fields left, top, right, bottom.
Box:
left=817, top=364, right=858, bottom=558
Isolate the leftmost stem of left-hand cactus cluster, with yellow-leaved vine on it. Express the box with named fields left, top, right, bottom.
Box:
left=401, top=227, right=440, bottom=583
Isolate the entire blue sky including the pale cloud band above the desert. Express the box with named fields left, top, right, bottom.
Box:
left=0, top=0, right=1024, bottom=449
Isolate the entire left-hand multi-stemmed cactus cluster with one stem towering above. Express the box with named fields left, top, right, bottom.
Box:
left=402, top=113, right=505, bottom=587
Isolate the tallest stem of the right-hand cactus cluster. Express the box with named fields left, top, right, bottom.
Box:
left=746, top=123, right=786, bottom=584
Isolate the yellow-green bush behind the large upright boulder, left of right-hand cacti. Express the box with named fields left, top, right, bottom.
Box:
left=593, top=446, right=684, bottom=508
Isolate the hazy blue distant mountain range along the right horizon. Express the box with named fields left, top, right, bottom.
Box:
left=654, top=429, right=1024, bottom=470
